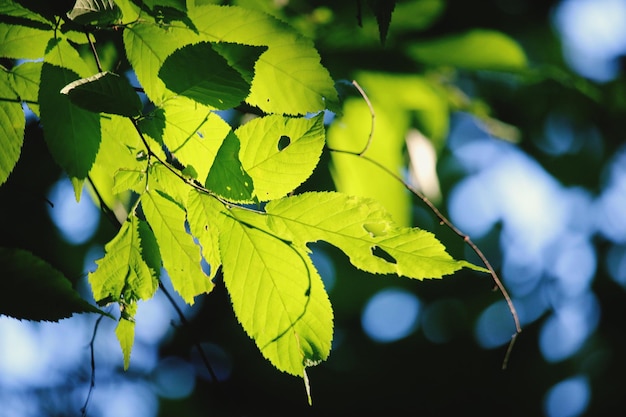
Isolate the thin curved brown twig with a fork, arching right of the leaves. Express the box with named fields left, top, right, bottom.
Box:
left=329, top=81, right=522, bottom=369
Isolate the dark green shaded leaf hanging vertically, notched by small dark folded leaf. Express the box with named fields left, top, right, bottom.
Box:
left=39, top=63, right=101, bottom=178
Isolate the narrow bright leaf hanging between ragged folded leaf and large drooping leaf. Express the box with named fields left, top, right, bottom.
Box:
left=141, top=191, right=213, bottom=305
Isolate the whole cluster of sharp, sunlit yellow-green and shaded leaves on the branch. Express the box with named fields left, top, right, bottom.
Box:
left=0, top=0, right=477, bottom=392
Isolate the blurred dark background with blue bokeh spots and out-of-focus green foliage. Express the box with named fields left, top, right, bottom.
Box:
left=0, top=0, right=626, bottom=417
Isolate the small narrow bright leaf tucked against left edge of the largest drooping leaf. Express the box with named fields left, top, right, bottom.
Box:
left=187, top=189, right=224, bottom=279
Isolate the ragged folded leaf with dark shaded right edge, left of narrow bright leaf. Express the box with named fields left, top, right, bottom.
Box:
left=89, top=215, right=161, bottom=304
